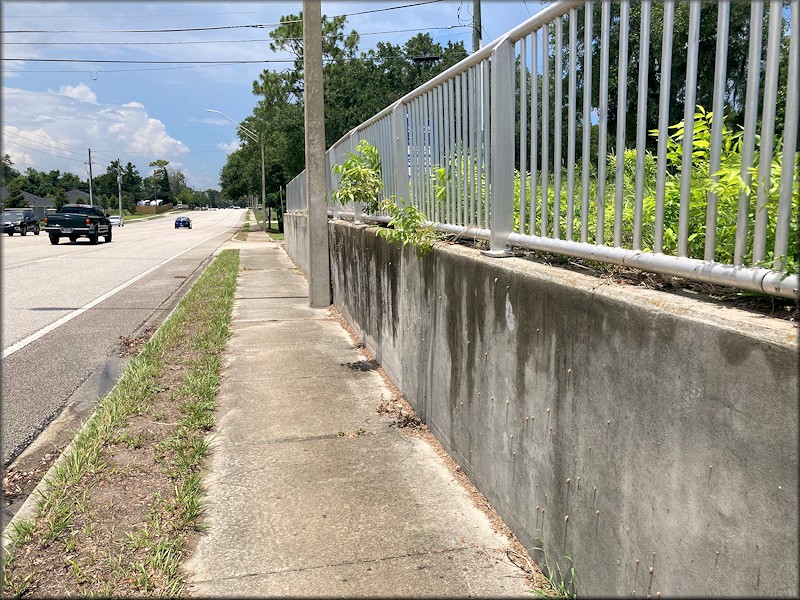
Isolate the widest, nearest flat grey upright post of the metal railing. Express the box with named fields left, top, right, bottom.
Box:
left=485, top=39, right=515, bottom=256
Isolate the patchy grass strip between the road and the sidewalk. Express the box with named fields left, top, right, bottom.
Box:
left=3, top=250, right=239, bottom=597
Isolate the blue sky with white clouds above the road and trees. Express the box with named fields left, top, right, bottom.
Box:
left=0, top=0, right=542, bottom=191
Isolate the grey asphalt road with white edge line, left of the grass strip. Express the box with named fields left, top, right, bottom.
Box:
left=0, top=209, right=245, bottom=468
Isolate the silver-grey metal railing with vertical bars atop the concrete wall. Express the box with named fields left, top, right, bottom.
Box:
left=287, top=0, right=800, bottom=298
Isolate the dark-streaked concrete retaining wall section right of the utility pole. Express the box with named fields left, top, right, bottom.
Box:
left=322, top=221, right=798, bottom=597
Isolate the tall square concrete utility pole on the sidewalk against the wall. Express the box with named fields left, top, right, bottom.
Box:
left=303, top=0, right=331, bottom=308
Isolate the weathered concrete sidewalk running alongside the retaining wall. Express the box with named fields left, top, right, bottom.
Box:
left=184, top=231, right=530, bottom=597
